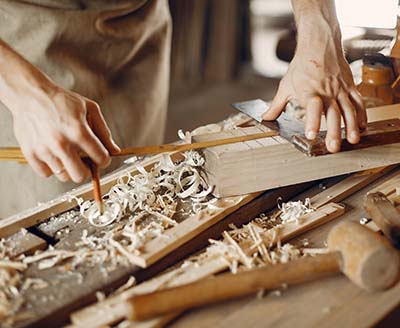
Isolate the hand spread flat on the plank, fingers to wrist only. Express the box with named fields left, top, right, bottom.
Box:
left=263, top=47, right=367, bottom=153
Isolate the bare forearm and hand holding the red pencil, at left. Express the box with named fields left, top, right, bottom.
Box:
left=0, top=41, right=119, bottom=183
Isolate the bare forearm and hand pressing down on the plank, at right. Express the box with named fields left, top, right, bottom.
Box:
left=264, top=0, right=367, bottom=152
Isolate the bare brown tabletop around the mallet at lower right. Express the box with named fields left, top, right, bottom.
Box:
left=171, top=169, right=400, bottom=328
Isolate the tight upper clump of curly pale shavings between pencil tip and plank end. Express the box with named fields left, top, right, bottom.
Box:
left=79, top=151, right=212, bottom=228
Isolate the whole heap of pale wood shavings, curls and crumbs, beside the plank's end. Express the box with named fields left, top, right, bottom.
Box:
left=69, top=151, right=219, bottom=263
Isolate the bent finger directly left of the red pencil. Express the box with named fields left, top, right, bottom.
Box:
left=56, top=147, right=90, bottom=183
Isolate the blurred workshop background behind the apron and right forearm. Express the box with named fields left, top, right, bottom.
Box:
left=166, top=0, right=398, bottom=142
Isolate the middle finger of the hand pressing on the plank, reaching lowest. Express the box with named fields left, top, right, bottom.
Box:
left=325, top=100, right=341, bottom=153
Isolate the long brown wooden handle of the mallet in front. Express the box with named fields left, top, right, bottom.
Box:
left=127, top=252, right=341, bottom=321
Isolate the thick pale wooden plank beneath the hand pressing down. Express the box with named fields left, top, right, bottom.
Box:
left=197, top=128, right=400, bottom=197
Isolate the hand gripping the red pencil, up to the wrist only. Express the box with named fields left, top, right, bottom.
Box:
left=9, top=81, right=120, bottom=183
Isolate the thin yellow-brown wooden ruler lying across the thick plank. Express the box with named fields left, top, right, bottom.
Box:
left=0, top=131, right=278, bottom=162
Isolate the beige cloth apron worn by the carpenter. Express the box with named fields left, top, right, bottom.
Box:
left=0, top=0, right=171, bottom=218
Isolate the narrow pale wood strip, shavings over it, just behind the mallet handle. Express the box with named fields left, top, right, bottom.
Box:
left=71, top=203, right=344, bottom=328
